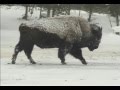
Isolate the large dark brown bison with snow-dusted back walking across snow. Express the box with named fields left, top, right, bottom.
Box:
left=12, top=16, right=102, bottom=65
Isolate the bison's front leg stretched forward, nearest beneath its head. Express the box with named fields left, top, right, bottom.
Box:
left=70, top=47, right=87, bottom=65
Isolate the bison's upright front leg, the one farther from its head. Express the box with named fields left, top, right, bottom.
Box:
left=58, top=44, right=72, bottom=65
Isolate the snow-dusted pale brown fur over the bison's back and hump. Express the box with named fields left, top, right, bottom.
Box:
left=21, top=16, right=90, bottom=41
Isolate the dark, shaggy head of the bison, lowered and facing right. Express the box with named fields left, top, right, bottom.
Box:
left=88, top=24, right=102, bottom=51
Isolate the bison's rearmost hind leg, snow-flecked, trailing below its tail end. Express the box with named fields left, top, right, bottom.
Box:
left=12, top=42, right=23, bottom=64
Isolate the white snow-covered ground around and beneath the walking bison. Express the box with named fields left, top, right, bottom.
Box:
left=0, top=6, right=120, bottom=86
